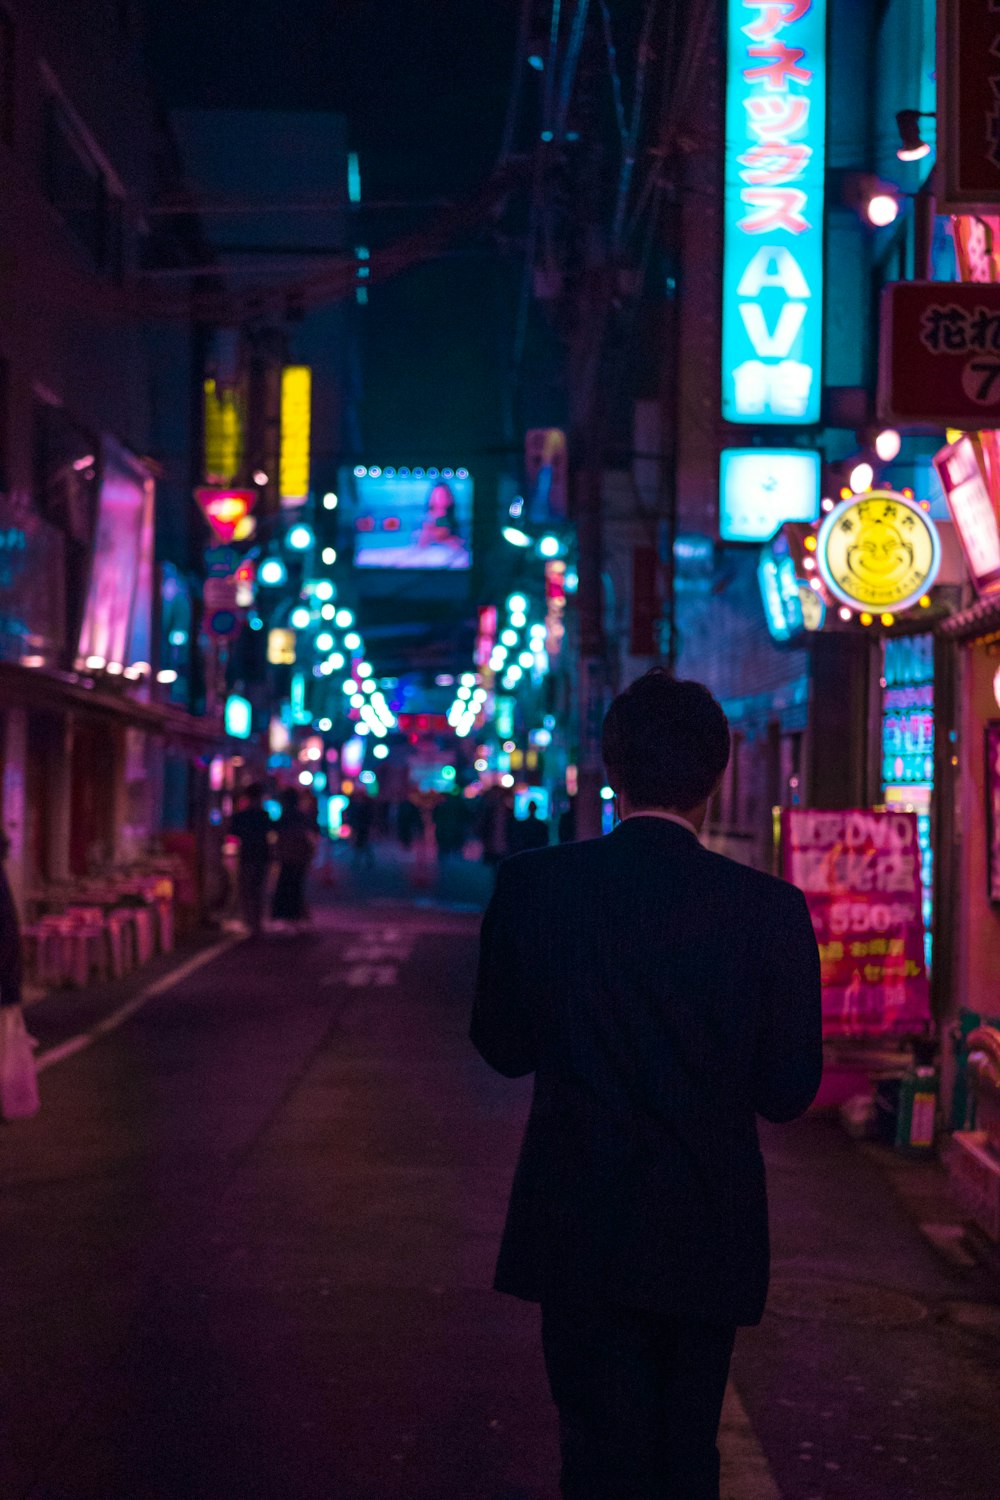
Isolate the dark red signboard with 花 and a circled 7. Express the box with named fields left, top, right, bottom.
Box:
left=879, top=282, right=1000, bottom=428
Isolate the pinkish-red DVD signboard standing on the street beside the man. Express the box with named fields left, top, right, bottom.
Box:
left=781, top=809, right=930, bottom=1037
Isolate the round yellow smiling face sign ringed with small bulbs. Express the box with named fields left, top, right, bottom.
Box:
left=817, top=489, right=942, bottom=612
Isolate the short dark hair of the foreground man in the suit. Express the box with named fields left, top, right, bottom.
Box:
left=601, top=668, right=729, bottom=813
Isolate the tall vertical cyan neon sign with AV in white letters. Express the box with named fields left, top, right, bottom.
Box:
left=723, top=0, right=826, bottom=425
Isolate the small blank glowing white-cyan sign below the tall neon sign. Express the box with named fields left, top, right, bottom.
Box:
left=718, top=449, right=820, bottom=542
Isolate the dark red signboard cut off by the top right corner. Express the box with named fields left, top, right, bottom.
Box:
left=937, top=0, right=1000, bottom=213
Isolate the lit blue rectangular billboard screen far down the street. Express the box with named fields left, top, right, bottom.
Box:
left=354, top=467, right=472, bottom=572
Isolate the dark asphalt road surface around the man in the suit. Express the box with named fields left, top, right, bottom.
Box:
left=0, top=870, right=1000, bottom=1500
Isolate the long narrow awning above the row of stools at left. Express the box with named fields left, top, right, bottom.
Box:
left=0, top=662, right=225, bottom=749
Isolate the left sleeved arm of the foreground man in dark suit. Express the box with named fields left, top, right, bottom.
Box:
left=469, top=866, right=537, bottom=1079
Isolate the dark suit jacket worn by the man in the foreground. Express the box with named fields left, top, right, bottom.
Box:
left=472, top=816, right=822, bottom=1323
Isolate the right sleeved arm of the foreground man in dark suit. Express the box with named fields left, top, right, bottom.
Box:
left=753, top=885, right=823, bottom=1124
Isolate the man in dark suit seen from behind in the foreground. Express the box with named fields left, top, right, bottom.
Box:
left=472, top=669, right=822, bottom=1500
